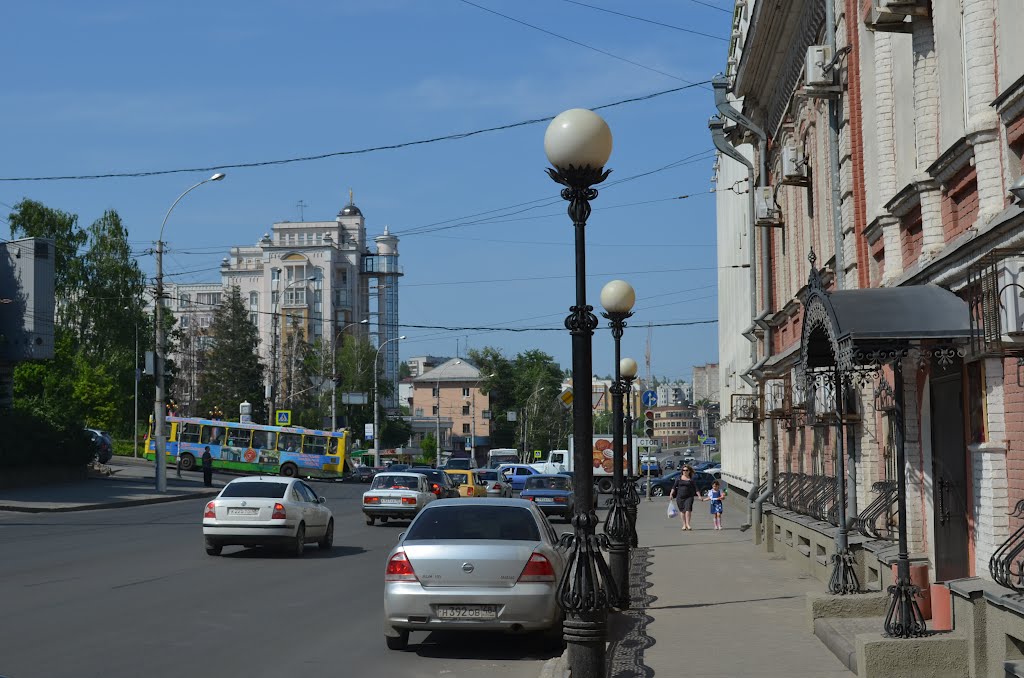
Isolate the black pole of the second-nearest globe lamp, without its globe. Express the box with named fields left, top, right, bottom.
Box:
left=604, top=312, right=626, bottom=609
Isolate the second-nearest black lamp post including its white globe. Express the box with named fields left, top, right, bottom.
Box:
left=601, top=281, right=637, bottom=608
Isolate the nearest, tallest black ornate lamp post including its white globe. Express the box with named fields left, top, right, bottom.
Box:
left=544, top=109, right=615, bottom=676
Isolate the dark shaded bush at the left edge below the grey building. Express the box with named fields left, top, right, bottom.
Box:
left=0, top=408, right=95, bottom=468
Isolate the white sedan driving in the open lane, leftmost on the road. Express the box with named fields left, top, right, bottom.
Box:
left=197, top=477, right=334, bottom=556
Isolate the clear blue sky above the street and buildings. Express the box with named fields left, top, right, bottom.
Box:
left=0, top=0, right=731, bottom=379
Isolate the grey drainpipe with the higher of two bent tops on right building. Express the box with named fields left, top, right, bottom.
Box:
left=712, top=75, right=775, bottom=544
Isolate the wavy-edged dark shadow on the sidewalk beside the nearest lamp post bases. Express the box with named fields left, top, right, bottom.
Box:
left=608, top=548, right=657, bottom=678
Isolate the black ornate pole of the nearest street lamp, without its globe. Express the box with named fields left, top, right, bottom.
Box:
left=548, top=166, right=617, bottom=677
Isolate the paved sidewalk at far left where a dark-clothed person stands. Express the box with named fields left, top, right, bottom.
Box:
left=0, top=457, right=224, bottom=513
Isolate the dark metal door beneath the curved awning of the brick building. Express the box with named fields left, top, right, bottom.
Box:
left=931, top=368, right=971, bottom=582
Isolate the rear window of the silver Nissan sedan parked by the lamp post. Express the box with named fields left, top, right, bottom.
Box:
left=406, top=504, right=541, bottom=542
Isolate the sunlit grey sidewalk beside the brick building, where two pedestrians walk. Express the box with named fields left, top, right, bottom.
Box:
left=542, top=499, right=856, bottom=678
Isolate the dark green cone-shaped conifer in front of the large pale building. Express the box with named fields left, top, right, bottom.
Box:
left=200, top=287, right=263, bottom=419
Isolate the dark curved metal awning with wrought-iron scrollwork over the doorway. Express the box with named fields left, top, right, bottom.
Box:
left=801, top=252, right=972, bottom=374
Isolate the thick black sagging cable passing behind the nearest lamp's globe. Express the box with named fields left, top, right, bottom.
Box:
left=0, top=80, right=711, bottom=181
